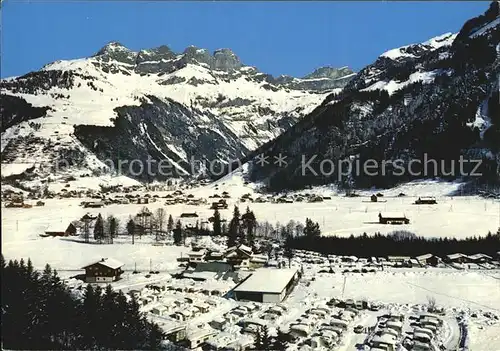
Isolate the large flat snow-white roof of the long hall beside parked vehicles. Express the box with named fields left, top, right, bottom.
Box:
left=234, top=268, right=297, bottom=294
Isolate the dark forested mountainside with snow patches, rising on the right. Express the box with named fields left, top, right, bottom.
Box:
left=244, top=1, right=500, bottom=190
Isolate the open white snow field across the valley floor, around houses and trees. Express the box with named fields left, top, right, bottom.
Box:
left=2, top=186, right=500, bottom=351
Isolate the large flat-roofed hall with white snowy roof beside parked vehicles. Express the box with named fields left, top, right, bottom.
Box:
left=233, top=268, right=298, bottom=303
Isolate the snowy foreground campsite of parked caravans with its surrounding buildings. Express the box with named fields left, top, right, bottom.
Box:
left=59, top=240, right=500, bottom=351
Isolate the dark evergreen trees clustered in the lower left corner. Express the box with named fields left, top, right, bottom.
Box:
left=1, top=256, right=163, bottom=350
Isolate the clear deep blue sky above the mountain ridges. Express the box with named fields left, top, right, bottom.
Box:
left=1, top=0, right=489, bottom=77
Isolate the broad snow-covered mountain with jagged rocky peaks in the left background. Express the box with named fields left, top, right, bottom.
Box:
left=1, top=42, right=355, bottom=180
